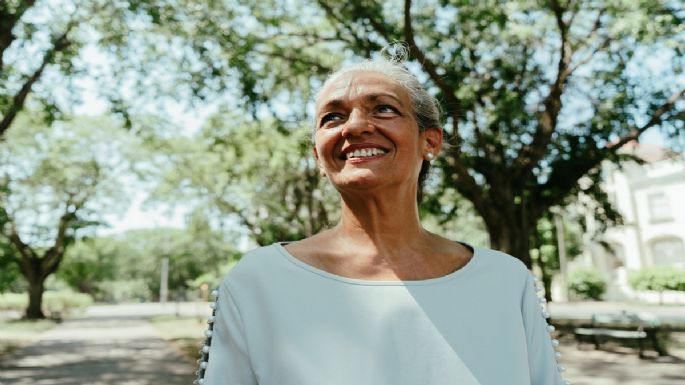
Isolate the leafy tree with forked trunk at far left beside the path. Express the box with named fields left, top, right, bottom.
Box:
left=0, top=117, right=131, bottom=319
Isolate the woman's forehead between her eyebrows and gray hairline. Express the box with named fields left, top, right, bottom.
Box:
left=316, top=71, right=411, bottom=112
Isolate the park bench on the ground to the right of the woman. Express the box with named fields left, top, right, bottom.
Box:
left=573, top=311, right=667, bottom=358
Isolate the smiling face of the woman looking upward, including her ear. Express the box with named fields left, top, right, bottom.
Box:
left=314, top=71, right=441, bottom=192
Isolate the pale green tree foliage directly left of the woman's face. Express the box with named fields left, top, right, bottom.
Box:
left=153, top=109, right=337, bottom=245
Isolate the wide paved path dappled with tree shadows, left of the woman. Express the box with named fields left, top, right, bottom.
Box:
left=0, top=307, right=195, bottom=385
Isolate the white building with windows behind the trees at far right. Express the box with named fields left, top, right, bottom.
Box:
left=570, top=143, right=685, bottom=303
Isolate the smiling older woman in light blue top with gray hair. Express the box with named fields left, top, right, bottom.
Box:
left=196, top=60, right=564, bottom=385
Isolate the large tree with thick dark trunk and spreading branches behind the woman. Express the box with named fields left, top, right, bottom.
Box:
left=123, top=0, right=685, bottom=266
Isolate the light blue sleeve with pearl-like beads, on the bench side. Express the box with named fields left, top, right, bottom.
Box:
left=521, top=274, right=571, bottom=385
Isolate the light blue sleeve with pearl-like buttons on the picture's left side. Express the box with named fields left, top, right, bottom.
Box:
left=196, top=284, right=258, bottom=385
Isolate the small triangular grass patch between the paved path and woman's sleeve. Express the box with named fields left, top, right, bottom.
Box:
left=149, top=315, right=207, bottom=363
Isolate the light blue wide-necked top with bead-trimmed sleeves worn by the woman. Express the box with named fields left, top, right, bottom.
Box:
left=204, top=244, right=564, bottom=385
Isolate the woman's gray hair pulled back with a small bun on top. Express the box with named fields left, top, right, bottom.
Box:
left=312, top=56, right=441, bottom=203
